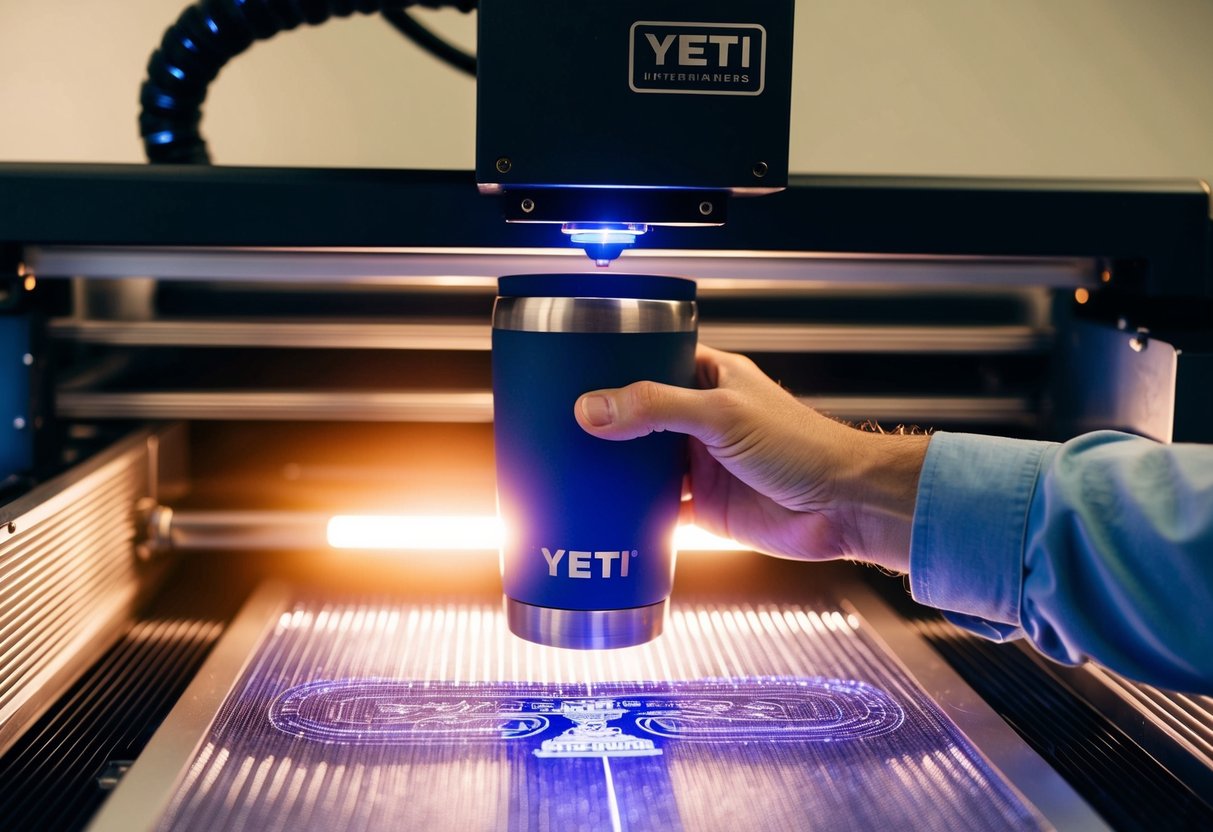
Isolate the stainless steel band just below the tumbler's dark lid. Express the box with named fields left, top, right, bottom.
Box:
left=492, top=297, right=699, bottom=332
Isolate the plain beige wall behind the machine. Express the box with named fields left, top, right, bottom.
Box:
left=0, top=0, right=1213, bottom=181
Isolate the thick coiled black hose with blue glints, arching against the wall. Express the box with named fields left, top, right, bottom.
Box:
left=139, top=0, right=478, bottom=165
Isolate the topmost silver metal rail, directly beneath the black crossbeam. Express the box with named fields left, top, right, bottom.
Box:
left=25, top=246, right=1098, bottom=291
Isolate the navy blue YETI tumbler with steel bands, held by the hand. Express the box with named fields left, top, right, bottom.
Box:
left=492, top=274, right=697, bottom=648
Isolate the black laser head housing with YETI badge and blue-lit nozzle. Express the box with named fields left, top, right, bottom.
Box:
left=475, top=0, right=795, bottom=263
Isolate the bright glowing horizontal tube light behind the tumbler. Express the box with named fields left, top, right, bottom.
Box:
left=328, top=514, right=747, bottom=552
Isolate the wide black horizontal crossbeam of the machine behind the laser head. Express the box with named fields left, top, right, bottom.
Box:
left=0, top=164, right=1213, bottom=300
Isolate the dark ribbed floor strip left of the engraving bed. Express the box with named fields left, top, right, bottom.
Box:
left=0, top=620, right=222, bottom=831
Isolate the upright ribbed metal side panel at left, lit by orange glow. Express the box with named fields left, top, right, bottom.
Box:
left=0, top=434, right=158, bottom=750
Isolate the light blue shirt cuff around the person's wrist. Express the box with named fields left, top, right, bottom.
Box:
left=910, top=432, right=1058, bottom=627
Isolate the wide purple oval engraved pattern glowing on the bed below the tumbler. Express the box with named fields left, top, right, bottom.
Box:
left=269, top=678, right=905, bottom=745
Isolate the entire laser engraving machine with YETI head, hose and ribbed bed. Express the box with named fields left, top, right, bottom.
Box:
left=0, top=0, right=1213, bottom=832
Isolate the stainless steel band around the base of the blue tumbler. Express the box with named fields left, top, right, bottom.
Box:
left=506, top=597, right=668, bottom=650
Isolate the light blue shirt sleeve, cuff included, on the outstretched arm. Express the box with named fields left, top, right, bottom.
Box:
left=910, top=431, right=1213, bottom=693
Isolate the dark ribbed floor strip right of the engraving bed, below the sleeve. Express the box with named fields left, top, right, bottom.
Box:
left=913, top=619, right=1213, bottom=832
